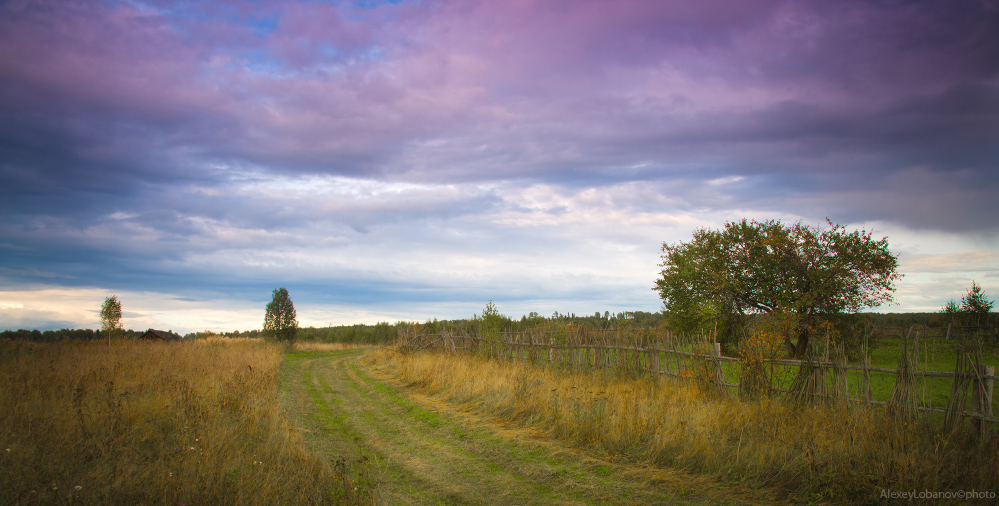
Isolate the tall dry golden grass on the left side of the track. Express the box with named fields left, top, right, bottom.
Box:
left=0, top=339, right=367, bottom=504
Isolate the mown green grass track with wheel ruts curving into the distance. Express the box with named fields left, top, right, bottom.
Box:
left=281, top=350, right=755, bottom=505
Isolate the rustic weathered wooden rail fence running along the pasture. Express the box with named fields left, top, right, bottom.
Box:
left=399, top=325, right=999, bottom=437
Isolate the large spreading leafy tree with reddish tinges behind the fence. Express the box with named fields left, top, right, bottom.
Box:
left=653, top=219, right=901, bottom=356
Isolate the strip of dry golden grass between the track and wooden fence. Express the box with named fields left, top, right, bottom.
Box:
left=374, top=352, right=999, bottom=502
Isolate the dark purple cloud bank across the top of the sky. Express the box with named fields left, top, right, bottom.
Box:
left=3, top=2, right=999, bottom=185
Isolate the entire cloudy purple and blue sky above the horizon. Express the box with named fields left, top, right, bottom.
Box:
left=0, top=0, right=999, bottom=332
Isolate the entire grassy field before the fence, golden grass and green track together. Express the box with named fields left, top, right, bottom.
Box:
left=0, top=339, right=999, bottom=505
